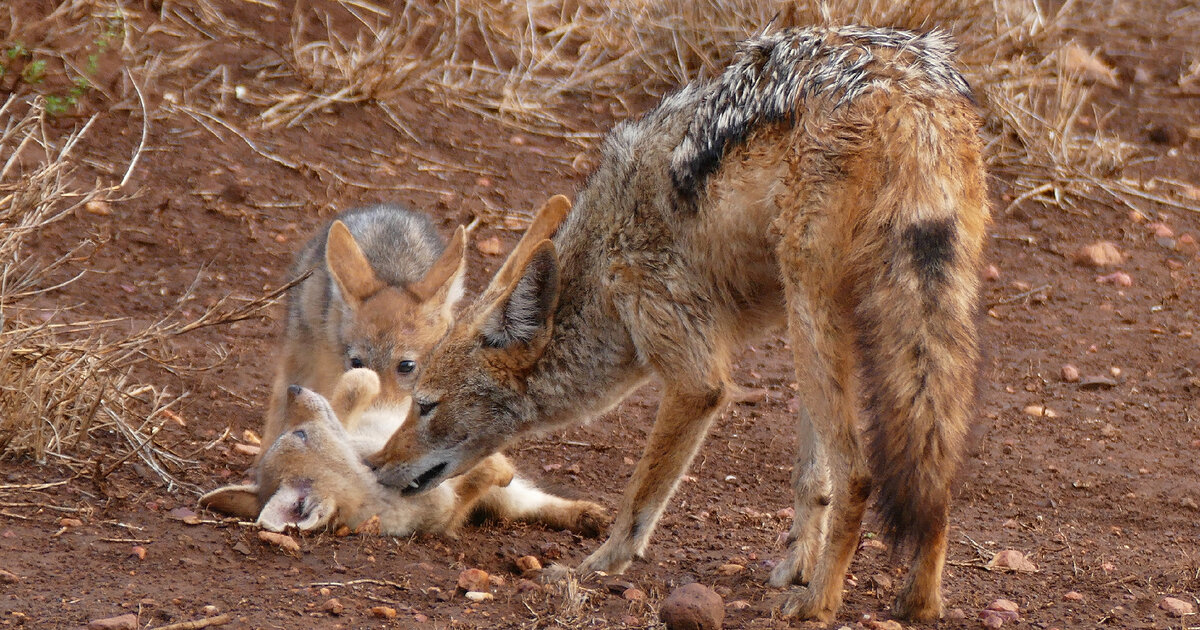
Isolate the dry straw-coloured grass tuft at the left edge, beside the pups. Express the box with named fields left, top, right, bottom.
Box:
left=0, top=96, right=280, bottom=486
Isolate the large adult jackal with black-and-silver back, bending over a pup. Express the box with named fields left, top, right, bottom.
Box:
left=372, top=28, right=989, bottom=622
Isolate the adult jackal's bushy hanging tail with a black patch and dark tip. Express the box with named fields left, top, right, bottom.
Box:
left=854, top=103, right=989, bottom=546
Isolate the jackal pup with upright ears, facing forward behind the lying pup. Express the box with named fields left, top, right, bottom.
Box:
left=263, top=204, right=467, bottom=446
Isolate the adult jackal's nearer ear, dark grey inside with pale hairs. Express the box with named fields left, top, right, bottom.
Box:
left=480, top=240, right=558, bottom=348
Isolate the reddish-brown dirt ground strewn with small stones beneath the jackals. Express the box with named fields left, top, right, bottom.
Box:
left=0, top=1, right=1200, bottom=628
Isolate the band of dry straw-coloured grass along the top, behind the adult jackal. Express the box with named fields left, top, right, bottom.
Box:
left=157, top=0, right=1200, bottom=218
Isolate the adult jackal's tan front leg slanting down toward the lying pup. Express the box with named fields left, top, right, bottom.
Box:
left=580, top=382, right=726, bottom=574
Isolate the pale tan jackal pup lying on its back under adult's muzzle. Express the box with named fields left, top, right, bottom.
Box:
left=200, top=368, right=605, bottom=536
